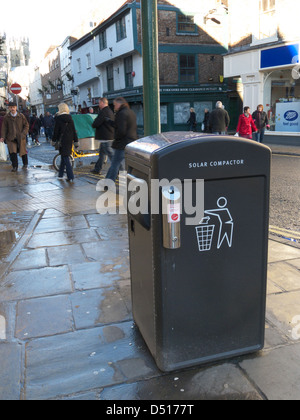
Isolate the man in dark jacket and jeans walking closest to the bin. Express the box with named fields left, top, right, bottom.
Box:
left=106, top=97, right=138, bottom=181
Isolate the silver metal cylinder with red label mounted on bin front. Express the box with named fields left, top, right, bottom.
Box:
left=162, top=185, right=181, bottom=249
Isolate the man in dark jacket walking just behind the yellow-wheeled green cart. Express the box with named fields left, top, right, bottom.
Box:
left=91, top=98, right=115, bottom=175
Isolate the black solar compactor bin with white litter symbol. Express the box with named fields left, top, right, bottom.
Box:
left=126, top=132, right=271, bottom=371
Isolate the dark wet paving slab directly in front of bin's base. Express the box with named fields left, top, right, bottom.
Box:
left=100, top=363, right=262, bottom=401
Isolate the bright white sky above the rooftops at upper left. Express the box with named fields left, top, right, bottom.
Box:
left=0, top=0, right=125, bottom=64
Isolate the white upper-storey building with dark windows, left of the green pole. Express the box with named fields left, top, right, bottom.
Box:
left=70, top=0, right=143, bottom=110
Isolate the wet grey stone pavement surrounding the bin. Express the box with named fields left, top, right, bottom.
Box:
left=0, top=144, right=300, bottom=401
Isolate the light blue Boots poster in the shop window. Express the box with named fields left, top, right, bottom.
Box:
left=275, top=102, right=300, bottom=133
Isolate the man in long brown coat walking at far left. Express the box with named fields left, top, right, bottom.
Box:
left=0, top=102, right=29, bottom=172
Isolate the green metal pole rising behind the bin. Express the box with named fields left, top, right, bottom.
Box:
left=141, top=0, right=161, bottom=136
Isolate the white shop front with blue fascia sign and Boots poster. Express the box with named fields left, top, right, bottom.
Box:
left=224, top=42, right=300, bottom=145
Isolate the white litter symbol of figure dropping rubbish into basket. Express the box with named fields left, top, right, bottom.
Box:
left=196, top=197, right=234, bottom=252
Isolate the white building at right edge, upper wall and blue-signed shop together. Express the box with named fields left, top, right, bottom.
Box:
left=224, top=0, right=300, bottom=144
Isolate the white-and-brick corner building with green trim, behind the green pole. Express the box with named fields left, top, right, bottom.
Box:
left=70, top=0, right=230, bottom=131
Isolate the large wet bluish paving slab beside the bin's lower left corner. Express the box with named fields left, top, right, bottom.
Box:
left=24, top=322, right=159, bottom=400
